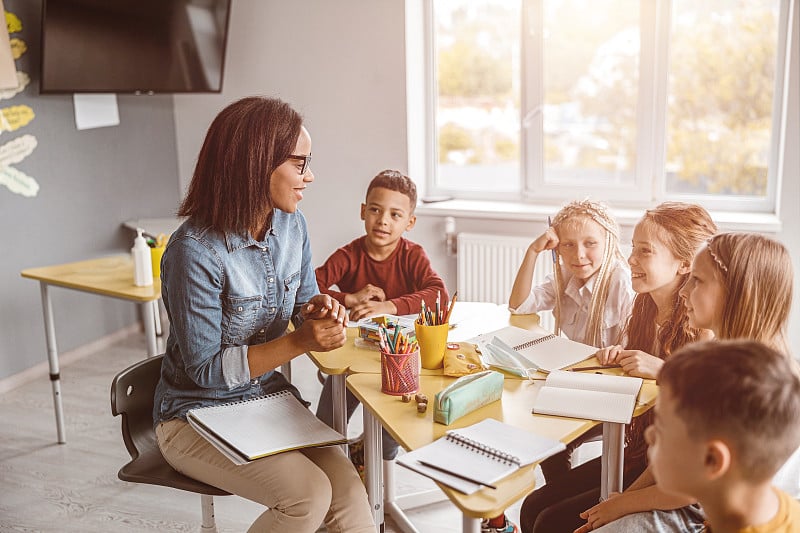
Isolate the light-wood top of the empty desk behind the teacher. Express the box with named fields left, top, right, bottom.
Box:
left=20, top=254, right=161, bottom=302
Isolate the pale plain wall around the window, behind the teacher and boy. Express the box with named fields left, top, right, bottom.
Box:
left=175, top=0, right=800, bottom=352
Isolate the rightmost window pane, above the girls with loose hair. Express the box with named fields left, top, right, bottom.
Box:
left=666, top=0, right=779, bottom=198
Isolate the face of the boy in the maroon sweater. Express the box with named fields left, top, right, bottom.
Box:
left=361, top=187, right=417, bottom=246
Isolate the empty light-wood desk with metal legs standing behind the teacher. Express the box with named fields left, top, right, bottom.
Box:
left=21, top=255, right=161, bottom=444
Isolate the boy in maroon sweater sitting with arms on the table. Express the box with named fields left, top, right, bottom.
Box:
left=315, top=170, right=449, bottom=460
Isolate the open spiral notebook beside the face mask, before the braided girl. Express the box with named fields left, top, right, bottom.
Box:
left=473, top=326, right=597, bottom=372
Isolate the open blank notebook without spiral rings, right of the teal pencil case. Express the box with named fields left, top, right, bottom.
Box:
left=533, top=370, right=642, bottom=424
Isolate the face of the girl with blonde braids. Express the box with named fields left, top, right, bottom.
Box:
left=558, top=218, right=606, bottom=281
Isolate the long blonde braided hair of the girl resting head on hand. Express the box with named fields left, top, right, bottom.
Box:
left=553, top=199, right=625, bottom=346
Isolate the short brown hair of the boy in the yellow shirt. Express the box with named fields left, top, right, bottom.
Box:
left=658, top=339, right=800, bottom=483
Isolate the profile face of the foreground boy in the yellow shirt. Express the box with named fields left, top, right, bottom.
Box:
left=645, top=386, right=707, bottom=498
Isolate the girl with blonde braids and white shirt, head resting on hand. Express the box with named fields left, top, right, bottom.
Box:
left=508, top=200, right=633, bottom=347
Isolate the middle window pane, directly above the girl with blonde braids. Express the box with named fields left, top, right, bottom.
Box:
left=542, top=0, right=639, bottom=186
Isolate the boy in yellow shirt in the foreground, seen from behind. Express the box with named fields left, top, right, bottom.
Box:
left=646, top=340, right=800, bottom=533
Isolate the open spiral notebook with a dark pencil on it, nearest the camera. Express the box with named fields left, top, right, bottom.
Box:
left=397, top=418, right=565, bottom=494
